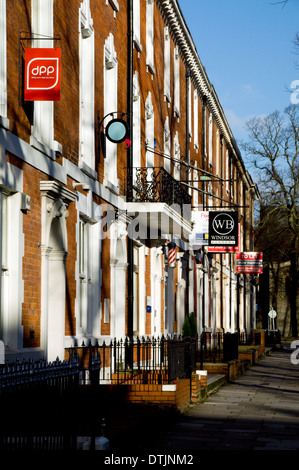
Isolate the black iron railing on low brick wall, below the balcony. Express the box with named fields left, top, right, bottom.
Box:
left=67, top=336, right=197, bottom=384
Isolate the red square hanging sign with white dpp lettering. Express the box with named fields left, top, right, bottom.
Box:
left=24, top=48, right=61, bottom=101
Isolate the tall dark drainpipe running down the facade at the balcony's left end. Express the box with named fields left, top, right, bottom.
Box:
left=127, top=0, right=134, bottom=338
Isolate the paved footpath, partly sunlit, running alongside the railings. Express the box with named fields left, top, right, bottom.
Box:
left=111, top=344, right=299, bottom=455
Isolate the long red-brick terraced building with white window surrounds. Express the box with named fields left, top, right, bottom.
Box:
left=0, top=0, right=258, bottom=361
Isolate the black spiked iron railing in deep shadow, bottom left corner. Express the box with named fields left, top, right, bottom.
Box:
left=0, top=358, right=79, bottom=451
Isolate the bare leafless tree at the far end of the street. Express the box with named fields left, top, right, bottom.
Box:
left=241, top=105, right=299, bottom=336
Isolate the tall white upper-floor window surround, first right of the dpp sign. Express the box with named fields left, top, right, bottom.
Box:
left=79, top=0, right=96, bottom=178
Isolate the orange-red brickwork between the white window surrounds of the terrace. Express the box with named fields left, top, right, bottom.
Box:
left=2, top=0, right=258, bottom=356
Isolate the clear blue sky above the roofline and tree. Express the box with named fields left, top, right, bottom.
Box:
left=179, top=0, right=299, bottom=142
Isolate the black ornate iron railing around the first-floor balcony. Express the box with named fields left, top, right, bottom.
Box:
left=127, top=167, right=192, bottom=214
